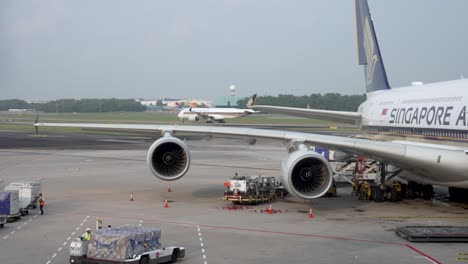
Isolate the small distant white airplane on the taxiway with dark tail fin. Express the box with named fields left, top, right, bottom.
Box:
left=177, top=94, right=257, bottom=123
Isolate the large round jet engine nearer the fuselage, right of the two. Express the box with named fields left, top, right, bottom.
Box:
left=281, top=150, right=333, bottom=199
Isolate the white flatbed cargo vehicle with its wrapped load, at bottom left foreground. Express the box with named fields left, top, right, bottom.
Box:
left=70, top=225, right=185, bottom=264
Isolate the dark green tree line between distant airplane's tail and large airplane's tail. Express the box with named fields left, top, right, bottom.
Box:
left=237, top=93, right=366, bottom=111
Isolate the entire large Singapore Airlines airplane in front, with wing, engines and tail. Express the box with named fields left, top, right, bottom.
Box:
left=35, top=0, right=468, bottom=199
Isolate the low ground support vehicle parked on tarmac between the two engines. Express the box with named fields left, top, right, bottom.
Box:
left=223, top=175, right=276, bottom=204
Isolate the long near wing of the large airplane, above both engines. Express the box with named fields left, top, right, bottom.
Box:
left=34, top=120, right=468, bottom=187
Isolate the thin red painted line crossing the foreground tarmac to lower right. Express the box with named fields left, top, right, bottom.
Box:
left=44, top=211, right=441, bottom=264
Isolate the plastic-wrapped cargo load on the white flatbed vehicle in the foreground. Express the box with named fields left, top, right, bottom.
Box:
left=88, top=225, right=161, bottom=261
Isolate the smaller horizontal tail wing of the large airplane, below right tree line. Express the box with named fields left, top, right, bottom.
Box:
left=252, top=105, right=361, bottom=124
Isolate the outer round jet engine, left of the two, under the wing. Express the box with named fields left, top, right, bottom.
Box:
left=146, top=137, right=190, bottom=181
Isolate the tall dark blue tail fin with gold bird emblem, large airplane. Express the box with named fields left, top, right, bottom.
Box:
left=355, top=0, right=390, bottom=93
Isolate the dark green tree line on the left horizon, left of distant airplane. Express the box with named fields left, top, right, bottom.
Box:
left=0, top=99, right=146, bottom=113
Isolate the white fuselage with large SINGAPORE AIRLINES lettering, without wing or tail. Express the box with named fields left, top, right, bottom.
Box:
left=359, top=80, right=468, bottom=149
